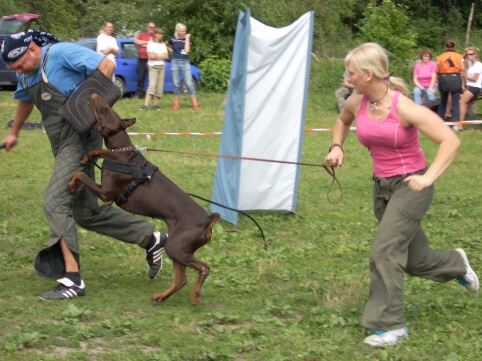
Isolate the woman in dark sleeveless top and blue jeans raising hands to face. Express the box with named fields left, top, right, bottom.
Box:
left=168, top=23, right=199, bottom=110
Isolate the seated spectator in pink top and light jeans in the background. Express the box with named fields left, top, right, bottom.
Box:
left=413, top=49, right=438, bottom=105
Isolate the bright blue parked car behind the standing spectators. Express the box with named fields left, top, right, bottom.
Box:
left=76, top=38, right=201, bottom=95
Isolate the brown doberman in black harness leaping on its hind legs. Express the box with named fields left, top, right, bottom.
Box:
left=69, top=94, right=219, bottom=305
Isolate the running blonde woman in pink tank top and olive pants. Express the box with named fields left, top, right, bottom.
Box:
left=326, top=43, right=479, bottom=347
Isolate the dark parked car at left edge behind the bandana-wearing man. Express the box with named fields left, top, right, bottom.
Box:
left=0, top=14, right=40, bottom=87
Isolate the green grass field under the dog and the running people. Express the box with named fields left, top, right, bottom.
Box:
left=0, top=79, right=482, bottom=361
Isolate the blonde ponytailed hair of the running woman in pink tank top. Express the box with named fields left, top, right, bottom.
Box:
left=345, top=43, right=408, bottom=94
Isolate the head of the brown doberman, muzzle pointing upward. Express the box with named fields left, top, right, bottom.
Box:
left=90, top=93, right=136, bottom=138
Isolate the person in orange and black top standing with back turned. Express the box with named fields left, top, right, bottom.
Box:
left=436, top=40, right=465, bottom=130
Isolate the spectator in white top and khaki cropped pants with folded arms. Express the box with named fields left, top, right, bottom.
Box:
left=141, top=28, right=169, bottom=110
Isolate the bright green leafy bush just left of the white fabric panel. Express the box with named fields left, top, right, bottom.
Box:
left=199, top=57, right=231, bottom=92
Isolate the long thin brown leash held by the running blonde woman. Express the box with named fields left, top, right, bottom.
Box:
left=135, top=145, right=343, bottom=204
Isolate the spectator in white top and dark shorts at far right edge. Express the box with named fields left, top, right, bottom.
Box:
left=459, top=47, right=482, bottom=130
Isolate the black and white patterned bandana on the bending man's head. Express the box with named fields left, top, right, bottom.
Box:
left=1, top=29, right=59, bottom=64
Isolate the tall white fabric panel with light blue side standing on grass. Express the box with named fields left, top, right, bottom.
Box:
left=211, top=9, right=314, bottom=224
